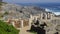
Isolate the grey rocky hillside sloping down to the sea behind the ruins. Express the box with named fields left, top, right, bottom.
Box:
left=2, top=4, right=52, bottom=18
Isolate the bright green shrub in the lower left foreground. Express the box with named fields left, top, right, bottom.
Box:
left=0, top=20, right=19, bottom=34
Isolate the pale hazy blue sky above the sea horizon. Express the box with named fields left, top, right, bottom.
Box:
left=3, top=0, right=60, bottom=3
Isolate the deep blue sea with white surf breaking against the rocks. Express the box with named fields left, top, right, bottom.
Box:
left=16, top=3, right=60, bottom=15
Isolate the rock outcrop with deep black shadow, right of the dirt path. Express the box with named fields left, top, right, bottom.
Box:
left=29, top=20, right=60, bottom=34
